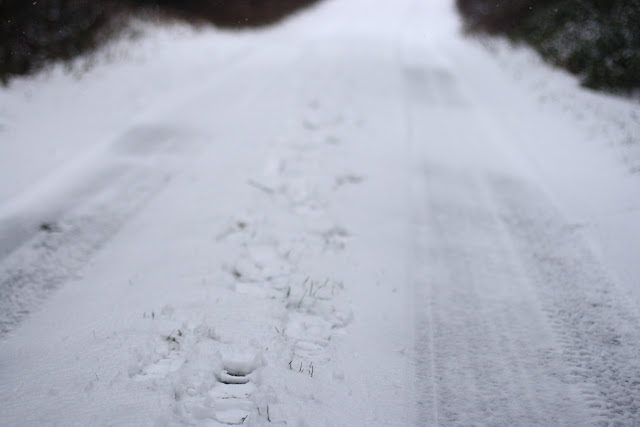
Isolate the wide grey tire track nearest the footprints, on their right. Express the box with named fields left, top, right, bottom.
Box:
left=415, top=167, right=588, bottom=425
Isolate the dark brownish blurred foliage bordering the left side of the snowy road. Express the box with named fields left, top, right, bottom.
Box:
left=0, top=0, right=317, bottom=83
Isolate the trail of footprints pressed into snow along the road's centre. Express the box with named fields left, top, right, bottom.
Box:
left=129, top=103, right=364, bottom=425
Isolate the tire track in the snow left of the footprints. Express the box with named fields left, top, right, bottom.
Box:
left=0, top=42, right=309, bottom=338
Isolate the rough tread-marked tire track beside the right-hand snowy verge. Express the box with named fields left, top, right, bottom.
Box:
left=490, top=177, right=640, bottom=425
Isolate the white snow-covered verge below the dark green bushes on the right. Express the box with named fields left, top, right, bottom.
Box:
left=468, top=38, right=640, bottom=300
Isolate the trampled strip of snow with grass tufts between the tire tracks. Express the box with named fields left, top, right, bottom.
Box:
left=129, top=98, right=363, bottom=425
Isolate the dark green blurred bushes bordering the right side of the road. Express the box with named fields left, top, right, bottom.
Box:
left=457, top=0, right=640, bottom=91
